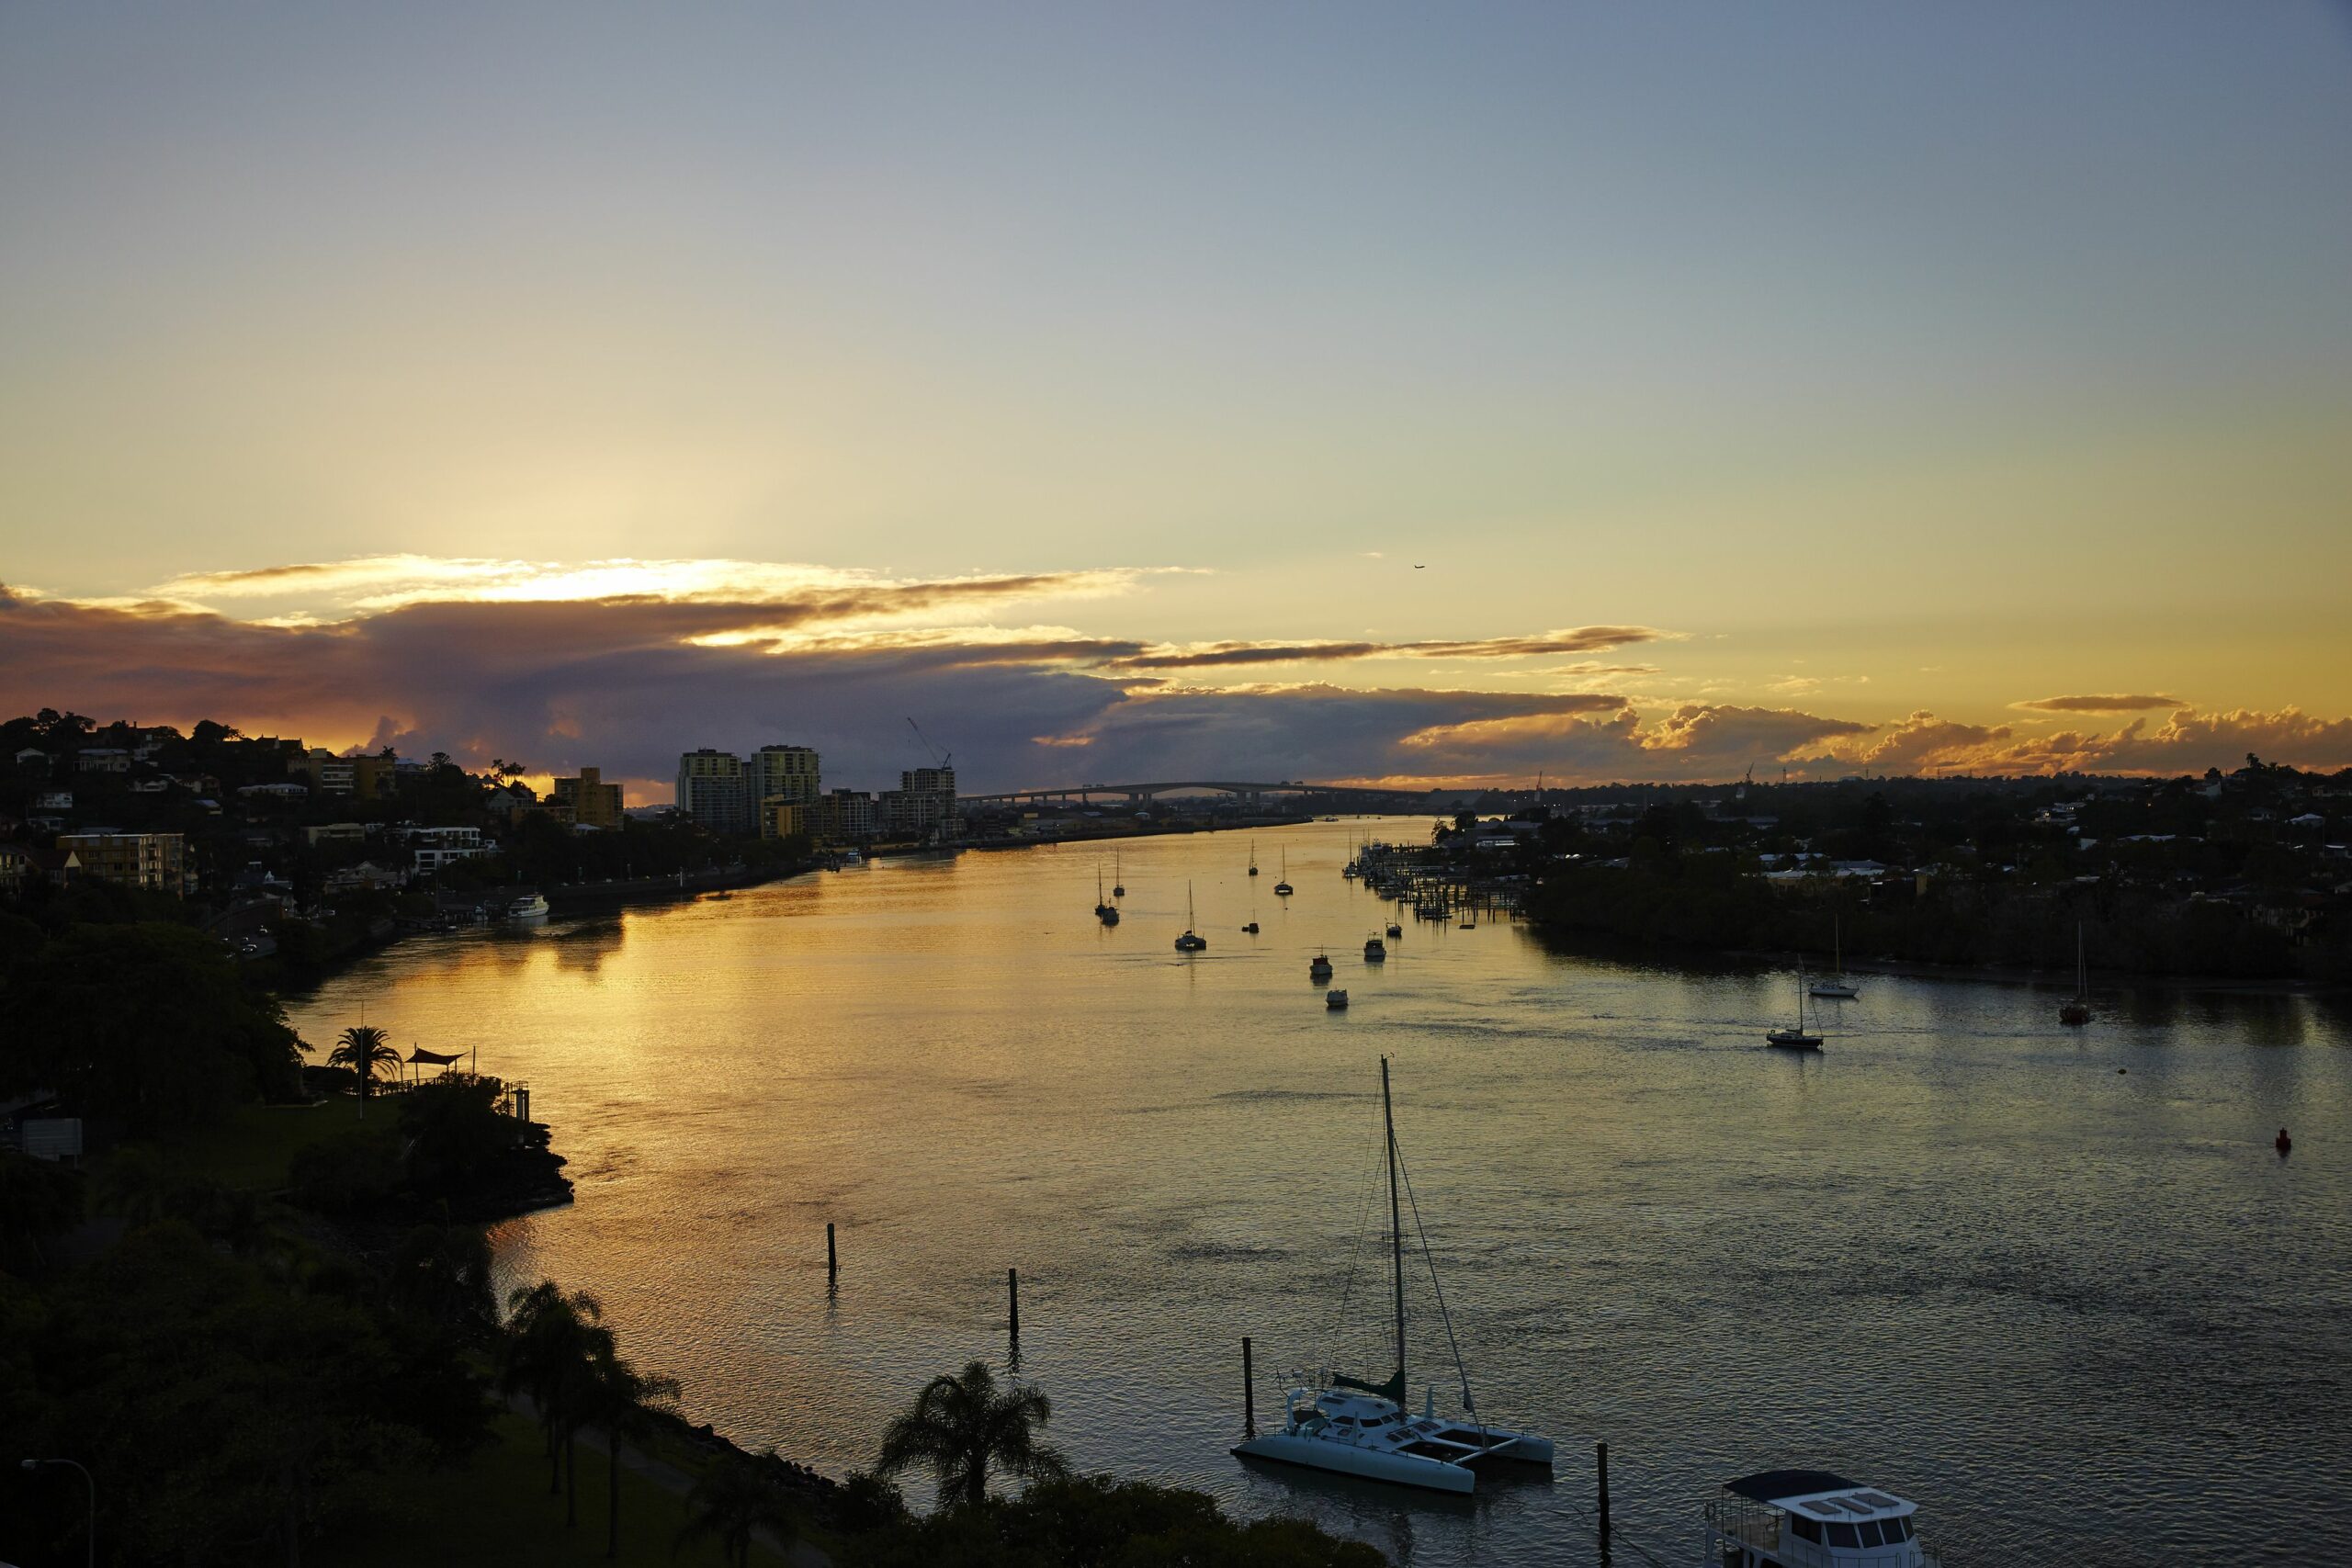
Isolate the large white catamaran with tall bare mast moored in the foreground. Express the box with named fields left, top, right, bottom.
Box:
left=1232, top=1055, right=1553, bottom=1493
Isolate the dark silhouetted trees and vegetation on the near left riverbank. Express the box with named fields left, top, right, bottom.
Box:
left=0, top=900, right=1381, bottom=1568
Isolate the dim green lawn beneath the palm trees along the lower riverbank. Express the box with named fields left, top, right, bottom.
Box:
left=318, top=1416, right=783, bottom=1568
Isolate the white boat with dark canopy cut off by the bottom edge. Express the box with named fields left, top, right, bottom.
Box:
left=1698, top=1470, right=1936, bottom=1568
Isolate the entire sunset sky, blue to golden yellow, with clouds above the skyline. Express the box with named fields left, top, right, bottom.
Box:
left=0, top=0, right=2352, bottom=799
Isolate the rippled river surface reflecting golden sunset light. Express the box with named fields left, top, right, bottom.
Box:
left=297, top=823, right=2352, bottom=1565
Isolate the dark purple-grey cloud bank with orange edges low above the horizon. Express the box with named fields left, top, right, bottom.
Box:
left=0, top=585, right=2352, bottom=790
